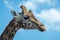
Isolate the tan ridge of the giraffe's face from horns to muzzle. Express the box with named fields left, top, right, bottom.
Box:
left=20, top=5, right=45, bottom=31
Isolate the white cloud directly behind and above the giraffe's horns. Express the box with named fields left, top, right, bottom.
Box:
left=18, top=0, right=37, bottom=11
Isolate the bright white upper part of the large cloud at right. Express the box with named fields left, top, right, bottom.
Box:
left=39, top=8, right=60, bottom=22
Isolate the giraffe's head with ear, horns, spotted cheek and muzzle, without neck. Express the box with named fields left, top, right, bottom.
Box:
left=11, top=5, right=45, bottom=31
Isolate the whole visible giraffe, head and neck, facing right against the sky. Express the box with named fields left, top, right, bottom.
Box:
left=0, top=5, right=45, bottom=40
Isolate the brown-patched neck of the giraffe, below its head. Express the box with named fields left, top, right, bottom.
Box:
left=0, top=19, right=20, bottom=40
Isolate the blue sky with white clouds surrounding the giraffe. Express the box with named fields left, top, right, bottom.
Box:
left=0, top=0, right=60, bottom=40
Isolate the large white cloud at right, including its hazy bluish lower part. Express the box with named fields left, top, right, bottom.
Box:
left=35, top=8, right=60, bottom=30
